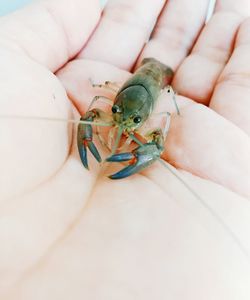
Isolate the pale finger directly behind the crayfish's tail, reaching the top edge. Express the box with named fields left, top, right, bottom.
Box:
left=140, top=0, right=209, bottom=70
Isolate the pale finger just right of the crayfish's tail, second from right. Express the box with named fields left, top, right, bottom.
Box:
left=173, top=12, right=242, bottom=104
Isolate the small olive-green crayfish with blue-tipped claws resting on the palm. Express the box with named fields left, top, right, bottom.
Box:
left=77, top=58, right=179, bottom=179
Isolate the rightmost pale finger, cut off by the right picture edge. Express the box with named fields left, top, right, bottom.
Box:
left=210, top=18, right=250, bottom=135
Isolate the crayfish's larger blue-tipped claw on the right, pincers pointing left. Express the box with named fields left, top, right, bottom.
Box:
left=106, top=142, right=161, bottom=179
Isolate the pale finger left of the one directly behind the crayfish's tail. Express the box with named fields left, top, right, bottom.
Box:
left=80, top=0, right=165, bottom=69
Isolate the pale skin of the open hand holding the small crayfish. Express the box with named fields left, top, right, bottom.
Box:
left=0, top=0, right=250, bottom=300
